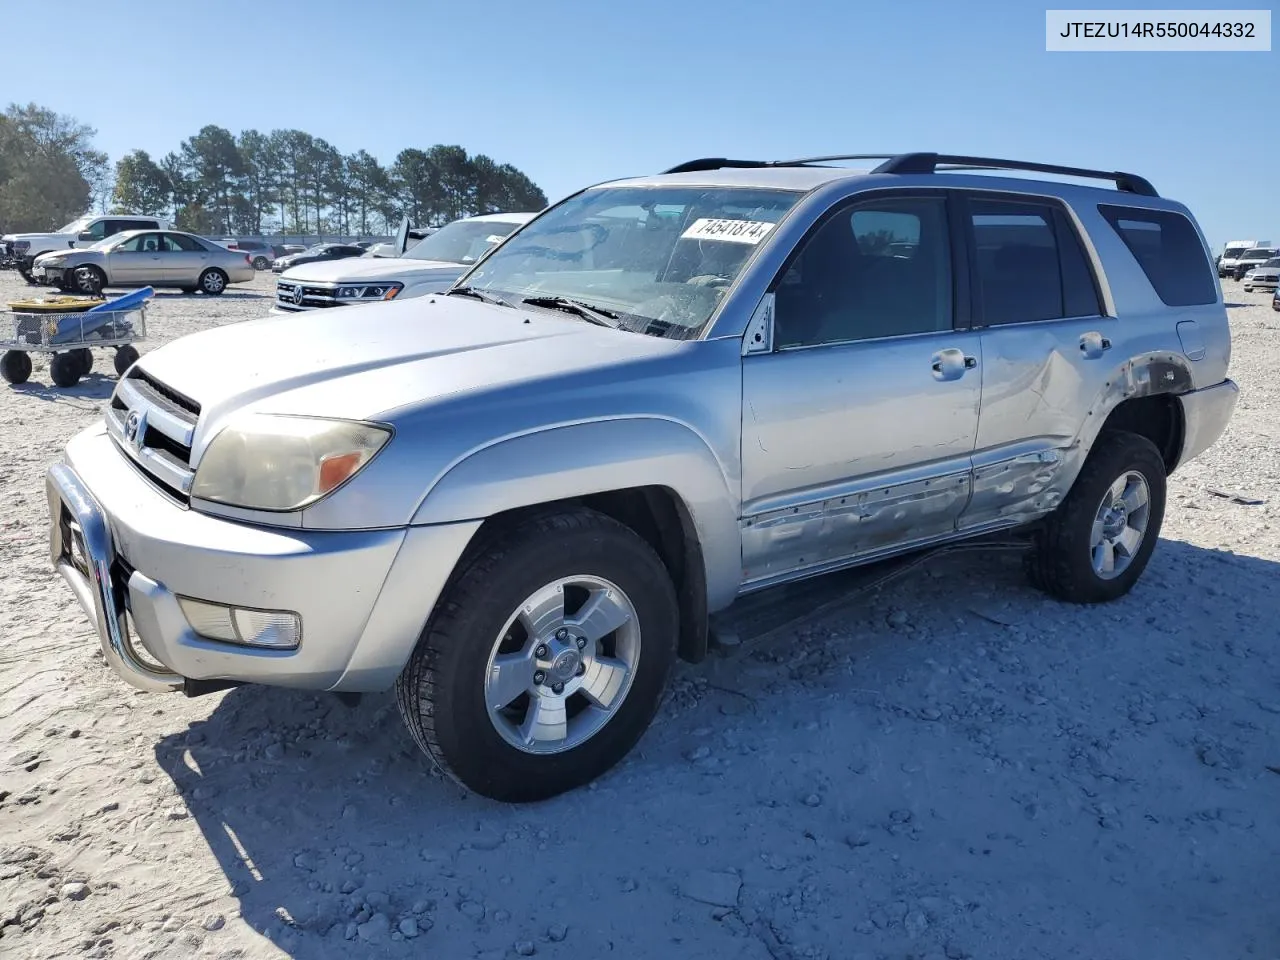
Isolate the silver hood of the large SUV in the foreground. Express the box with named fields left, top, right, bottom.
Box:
left=138, top=297, right=687, bottom=457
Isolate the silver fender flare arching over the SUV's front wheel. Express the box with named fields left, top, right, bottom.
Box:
left=411, top=416, right=742, bottom=611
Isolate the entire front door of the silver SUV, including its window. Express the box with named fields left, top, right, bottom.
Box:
left=741, top=191, right=982, bottom=585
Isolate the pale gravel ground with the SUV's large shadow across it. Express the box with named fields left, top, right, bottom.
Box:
left=0, top=274, right=1280, bottom=960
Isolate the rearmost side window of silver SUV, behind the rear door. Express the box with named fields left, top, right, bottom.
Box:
left=1098, top=204, right=1217, bottom=307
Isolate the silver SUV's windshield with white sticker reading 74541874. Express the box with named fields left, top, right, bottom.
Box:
left=460, top=186, right=800, bottom=339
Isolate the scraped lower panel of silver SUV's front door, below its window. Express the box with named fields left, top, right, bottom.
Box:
left=742, top=332, right=982, bottom=582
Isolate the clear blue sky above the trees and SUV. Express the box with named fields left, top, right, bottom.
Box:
left=0, top=0, right=1280, bottom=246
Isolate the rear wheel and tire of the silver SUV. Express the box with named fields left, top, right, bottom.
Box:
left=1027, top=430, right=1165, bottom=604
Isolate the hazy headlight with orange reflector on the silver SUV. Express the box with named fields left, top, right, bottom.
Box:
left=191, top=413, right=390, bottom=511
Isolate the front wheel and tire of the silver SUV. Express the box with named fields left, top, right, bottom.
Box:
left=396, top=509, right=678, bottom=803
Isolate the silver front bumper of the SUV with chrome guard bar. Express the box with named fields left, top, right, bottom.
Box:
left=46, top=428, right=479, bottom=691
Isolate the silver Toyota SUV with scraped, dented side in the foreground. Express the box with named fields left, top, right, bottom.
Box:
left=47, top=154, right=1236, bottom=801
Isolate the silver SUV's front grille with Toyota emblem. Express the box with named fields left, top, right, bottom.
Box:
left=106, top=366, right=200, bottom=503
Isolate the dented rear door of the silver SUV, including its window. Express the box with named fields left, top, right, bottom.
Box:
left=957, top=191, right=1119, bottom=530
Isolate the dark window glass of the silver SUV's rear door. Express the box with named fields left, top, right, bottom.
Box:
left=969, top=198, right=1102, bottom=325
